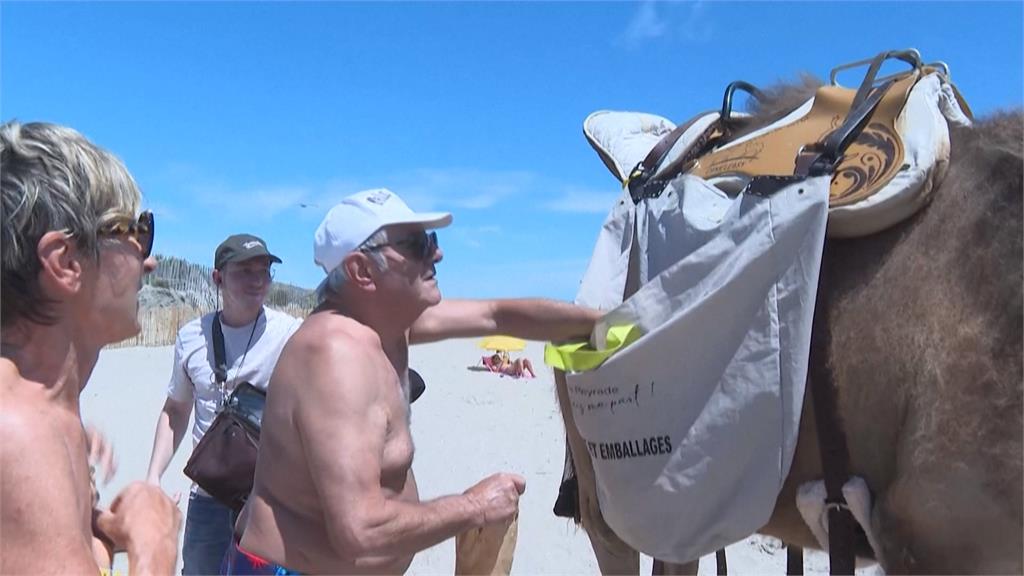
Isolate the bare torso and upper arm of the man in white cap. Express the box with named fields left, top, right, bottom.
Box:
left=242, top=312, right=419, bottom=574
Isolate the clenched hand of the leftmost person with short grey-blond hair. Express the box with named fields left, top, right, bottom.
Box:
left=93, top=482, right=181, bottom=574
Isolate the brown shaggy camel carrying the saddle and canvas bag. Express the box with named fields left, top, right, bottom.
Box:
left=555, top=77, right=1024, bottom=574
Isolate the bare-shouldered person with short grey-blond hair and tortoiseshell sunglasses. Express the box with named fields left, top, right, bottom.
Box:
left=0, top=122, right=181, bottom=575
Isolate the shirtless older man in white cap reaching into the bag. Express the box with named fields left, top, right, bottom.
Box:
left=228, top=190, right=597, bottom=574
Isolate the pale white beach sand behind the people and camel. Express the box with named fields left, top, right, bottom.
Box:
left=82, top=340, right=879, bottom=574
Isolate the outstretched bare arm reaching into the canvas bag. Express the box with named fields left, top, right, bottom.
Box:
left=409, top=298, right=602, bottom=343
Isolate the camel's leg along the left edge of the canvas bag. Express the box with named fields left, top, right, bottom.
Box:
left=555, top=370, right=640, bottom=574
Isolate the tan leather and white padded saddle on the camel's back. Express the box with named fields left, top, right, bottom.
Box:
left=584, top=49, right=972, bottom=238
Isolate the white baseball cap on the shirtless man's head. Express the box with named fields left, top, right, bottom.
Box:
left=313, top=188, right=452, bottom=273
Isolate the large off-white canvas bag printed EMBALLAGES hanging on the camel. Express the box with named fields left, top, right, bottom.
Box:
left=566, top=171, right=829, bottom=563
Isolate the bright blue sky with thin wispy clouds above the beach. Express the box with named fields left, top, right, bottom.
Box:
left=0, top=1, right=1024, bottom=299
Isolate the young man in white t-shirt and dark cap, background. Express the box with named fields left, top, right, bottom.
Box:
left=146, top=234, right=301, bottom=575
